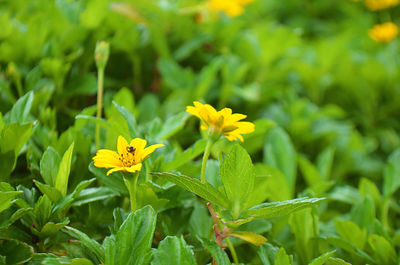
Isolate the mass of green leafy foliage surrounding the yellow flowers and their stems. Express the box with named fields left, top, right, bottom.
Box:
left=0, top=0, right=400, bottom=265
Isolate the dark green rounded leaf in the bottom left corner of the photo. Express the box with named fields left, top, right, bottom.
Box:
left=0, top=239, right=33, bottom=265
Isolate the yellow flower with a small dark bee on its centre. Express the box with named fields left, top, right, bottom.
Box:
left=93, top=136, right=164, bottom=176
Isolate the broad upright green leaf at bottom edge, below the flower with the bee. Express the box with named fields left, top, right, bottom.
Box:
left=105, top=206, right=156, bottom=265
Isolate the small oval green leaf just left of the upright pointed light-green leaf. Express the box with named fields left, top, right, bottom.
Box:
left=40, top=146, right=61, bottom=187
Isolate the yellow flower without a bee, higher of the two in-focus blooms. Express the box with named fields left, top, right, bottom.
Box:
left=186, top=101, right=254, bottom=142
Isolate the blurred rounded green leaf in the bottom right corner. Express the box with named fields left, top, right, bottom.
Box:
left=368, top=234, right=398, bottom=265
